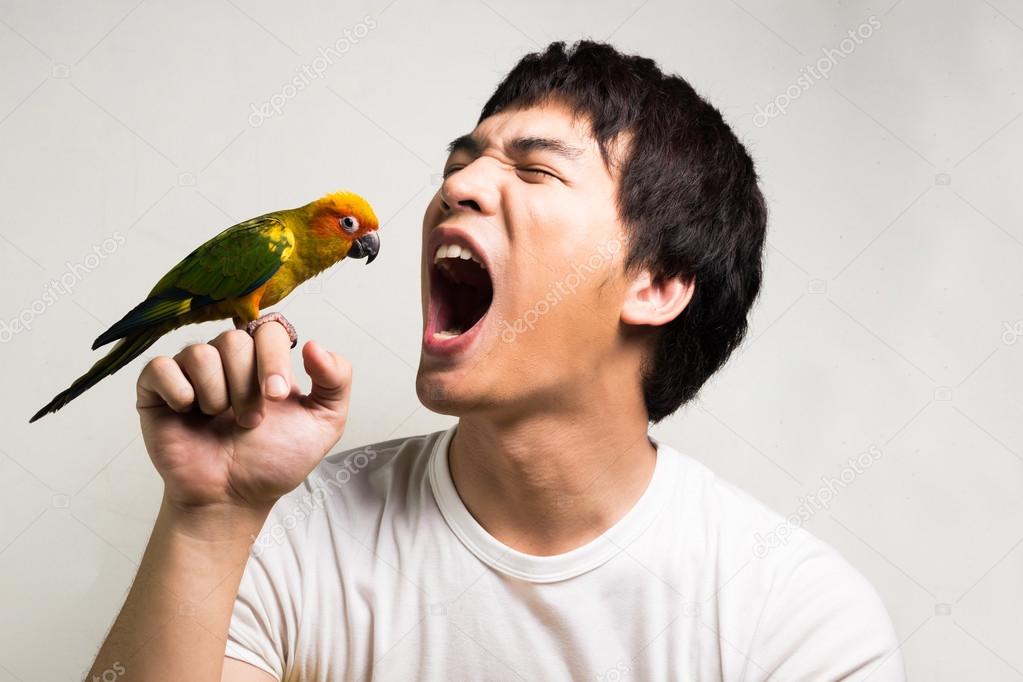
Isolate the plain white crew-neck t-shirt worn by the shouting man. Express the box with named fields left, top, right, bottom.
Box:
left=226, top=424, right=905, bottom=682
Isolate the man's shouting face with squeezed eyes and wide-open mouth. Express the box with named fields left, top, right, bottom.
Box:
left=416, top=102, right=626, bottom=415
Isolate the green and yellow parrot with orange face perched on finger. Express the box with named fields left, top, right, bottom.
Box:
left=29, top=190, right=380, bottom=423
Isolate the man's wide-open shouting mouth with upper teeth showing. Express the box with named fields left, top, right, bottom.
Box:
left=427, top=243, right=494, bottom=343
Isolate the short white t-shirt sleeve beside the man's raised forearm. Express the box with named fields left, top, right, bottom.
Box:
left=224, top=512, right=299, bottom=680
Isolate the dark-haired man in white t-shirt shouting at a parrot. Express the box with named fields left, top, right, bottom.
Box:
left=87, top=42, right=903, bottom=682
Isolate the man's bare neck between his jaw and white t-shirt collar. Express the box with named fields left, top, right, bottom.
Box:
left=449, top=404, right=657, bottom=556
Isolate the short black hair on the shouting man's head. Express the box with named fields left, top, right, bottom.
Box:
left=479, top=40, right=767, bottom=423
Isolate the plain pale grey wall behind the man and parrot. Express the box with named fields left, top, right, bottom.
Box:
left=0, top=0, right=1023, bottom=682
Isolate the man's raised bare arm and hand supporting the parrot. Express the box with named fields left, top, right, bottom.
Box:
left=86, top=324, right=351, bottom=682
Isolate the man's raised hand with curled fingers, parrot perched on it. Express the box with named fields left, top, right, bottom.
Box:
left=137, top=324, right=352, bottom=510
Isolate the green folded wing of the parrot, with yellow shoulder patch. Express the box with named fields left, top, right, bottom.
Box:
left=92, top=214, right=295, bottom=350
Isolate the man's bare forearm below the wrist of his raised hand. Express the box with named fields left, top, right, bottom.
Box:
left=86, top=499, right=269, bottom=682
